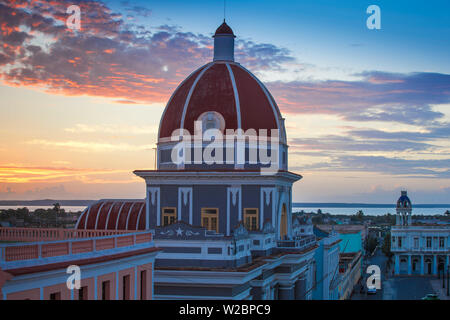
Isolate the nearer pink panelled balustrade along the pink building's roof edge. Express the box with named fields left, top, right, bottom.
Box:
left=0, top=231, right=153, bottom=263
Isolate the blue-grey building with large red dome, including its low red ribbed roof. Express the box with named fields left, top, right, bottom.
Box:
left=76, top=22, right=317, bottom=299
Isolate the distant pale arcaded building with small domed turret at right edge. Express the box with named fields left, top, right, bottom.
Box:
left=391, top=191, right=450, bottom=275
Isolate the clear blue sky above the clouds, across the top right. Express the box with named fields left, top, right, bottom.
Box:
left=110, top=0, right=450, bottom=73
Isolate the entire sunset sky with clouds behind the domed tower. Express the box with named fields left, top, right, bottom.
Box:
left=0, top=0, right=450, bottom=203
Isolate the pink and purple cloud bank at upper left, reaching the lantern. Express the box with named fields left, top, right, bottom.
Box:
left=0, top=0, right=291, bottom=103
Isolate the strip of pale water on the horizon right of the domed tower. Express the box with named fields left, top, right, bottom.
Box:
left=292, top=206, right=450, bottom=216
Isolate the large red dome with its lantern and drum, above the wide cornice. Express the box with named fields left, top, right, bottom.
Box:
left=157, top=21, right=287, bottom=170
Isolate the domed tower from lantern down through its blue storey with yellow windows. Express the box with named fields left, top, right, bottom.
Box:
left=134, top=21, right=302, bottom=239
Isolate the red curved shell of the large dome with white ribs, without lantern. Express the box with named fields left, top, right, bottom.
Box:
left=159, top=60, right=284, bottom=139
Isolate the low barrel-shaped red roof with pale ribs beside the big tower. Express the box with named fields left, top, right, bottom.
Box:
left=75, top=200, right=145, bottom=230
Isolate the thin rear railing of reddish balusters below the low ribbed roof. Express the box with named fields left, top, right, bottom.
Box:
left=0, top=228, right=134, bottom=242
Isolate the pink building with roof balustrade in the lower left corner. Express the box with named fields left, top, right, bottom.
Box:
left=0, top=228, right=158, bottom=300
